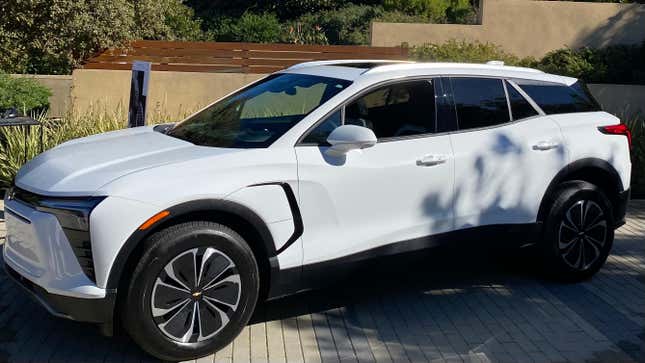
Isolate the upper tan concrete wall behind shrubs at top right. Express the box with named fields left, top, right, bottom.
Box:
left=371, top=0, right=645, bottom=57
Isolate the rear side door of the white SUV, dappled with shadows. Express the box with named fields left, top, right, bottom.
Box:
left=450, top=77, right=566, bottom=228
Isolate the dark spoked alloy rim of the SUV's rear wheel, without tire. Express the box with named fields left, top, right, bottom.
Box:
left=558, top=200, right=607, bottom=271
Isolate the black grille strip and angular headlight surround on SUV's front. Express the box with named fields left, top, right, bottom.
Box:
left=7, top=186, right=96, bottom=282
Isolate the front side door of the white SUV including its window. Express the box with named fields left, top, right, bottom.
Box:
left=296, top=79, right=454, bottom=264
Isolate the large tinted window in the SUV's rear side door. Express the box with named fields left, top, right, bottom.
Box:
left=451, top=78, right=510, bottom=130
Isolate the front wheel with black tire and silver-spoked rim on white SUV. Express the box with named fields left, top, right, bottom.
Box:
left=121, top=222, right=260, bottom=361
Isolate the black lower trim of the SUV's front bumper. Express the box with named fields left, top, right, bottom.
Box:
left=4, top=263, right=116, bottom=323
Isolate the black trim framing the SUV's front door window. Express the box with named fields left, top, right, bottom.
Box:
left=294, top=75, right=438, bottom=147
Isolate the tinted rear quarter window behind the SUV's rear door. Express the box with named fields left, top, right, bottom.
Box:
left=515, top=80, right=600, bottom=114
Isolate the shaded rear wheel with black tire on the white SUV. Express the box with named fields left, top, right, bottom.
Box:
left=541, top=181, right=614, bottom=282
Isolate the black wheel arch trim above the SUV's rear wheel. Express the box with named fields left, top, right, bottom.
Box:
left=537, top=158, right=625, bottom=222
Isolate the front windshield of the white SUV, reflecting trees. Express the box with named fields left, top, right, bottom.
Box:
left=167, top=73, right=351, bottom=148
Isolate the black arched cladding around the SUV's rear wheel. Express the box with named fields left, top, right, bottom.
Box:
left=537, top=158, right=624, bottom=222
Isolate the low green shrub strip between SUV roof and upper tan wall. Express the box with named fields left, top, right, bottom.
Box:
left=410, top=40, right=536, bottom=67
